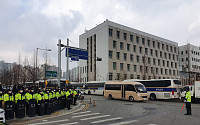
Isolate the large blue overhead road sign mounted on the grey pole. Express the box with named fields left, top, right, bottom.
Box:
left=66, top=47, right=88, bottom=60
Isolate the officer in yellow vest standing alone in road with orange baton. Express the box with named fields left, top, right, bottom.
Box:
left=185, top=87, right=192, bottom=115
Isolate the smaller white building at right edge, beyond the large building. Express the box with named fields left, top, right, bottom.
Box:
left=179, top=44, right=200, bottom=84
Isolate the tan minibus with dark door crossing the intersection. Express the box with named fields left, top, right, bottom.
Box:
left=104, top=81, right=147, bottom=102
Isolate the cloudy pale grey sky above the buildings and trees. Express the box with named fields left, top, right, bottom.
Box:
left=0, top=0, right=200, bottom=70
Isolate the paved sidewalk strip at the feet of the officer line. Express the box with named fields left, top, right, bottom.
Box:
left=6, top=101, right=85, bottom=125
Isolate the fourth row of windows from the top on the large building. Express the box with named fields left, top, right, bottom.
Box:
left=113, top=62, right=177, bottom=75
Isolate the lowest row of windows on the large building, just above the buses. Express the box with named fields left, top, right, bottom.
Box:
left=109, top=72, right=178, bottom=80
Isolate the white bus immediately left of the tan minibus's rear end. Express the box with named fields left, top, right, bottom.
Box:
left=83, top=81, right=106, bottom=95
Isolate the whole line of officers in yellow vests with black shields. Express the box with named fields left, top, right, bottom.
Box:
left=0, top=88, right=78, bottom=120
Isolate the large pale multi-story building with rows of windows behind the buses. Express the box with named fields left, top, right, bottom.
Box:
left=79, top=20, right=178, bottom=82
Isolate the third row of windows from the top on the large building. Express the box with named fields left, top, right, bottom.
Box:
left=108, top=51, right=178, bottom=63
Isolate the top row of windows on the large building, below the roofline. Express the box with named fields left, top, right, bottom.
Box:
left=109, top=29, right=177, bottom=53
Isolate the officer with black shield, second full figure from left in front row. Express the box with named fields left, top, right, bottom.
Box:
left=15, top=90, right=25, bottom=118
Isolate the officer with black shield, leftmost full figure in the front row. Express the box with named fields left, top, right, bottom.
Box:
left=3, top=89, right=14, bottom=120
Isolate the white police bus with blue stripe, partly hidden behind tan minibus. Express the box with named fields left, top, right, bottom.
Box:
left=125, top=79, right=182, bottom=100
